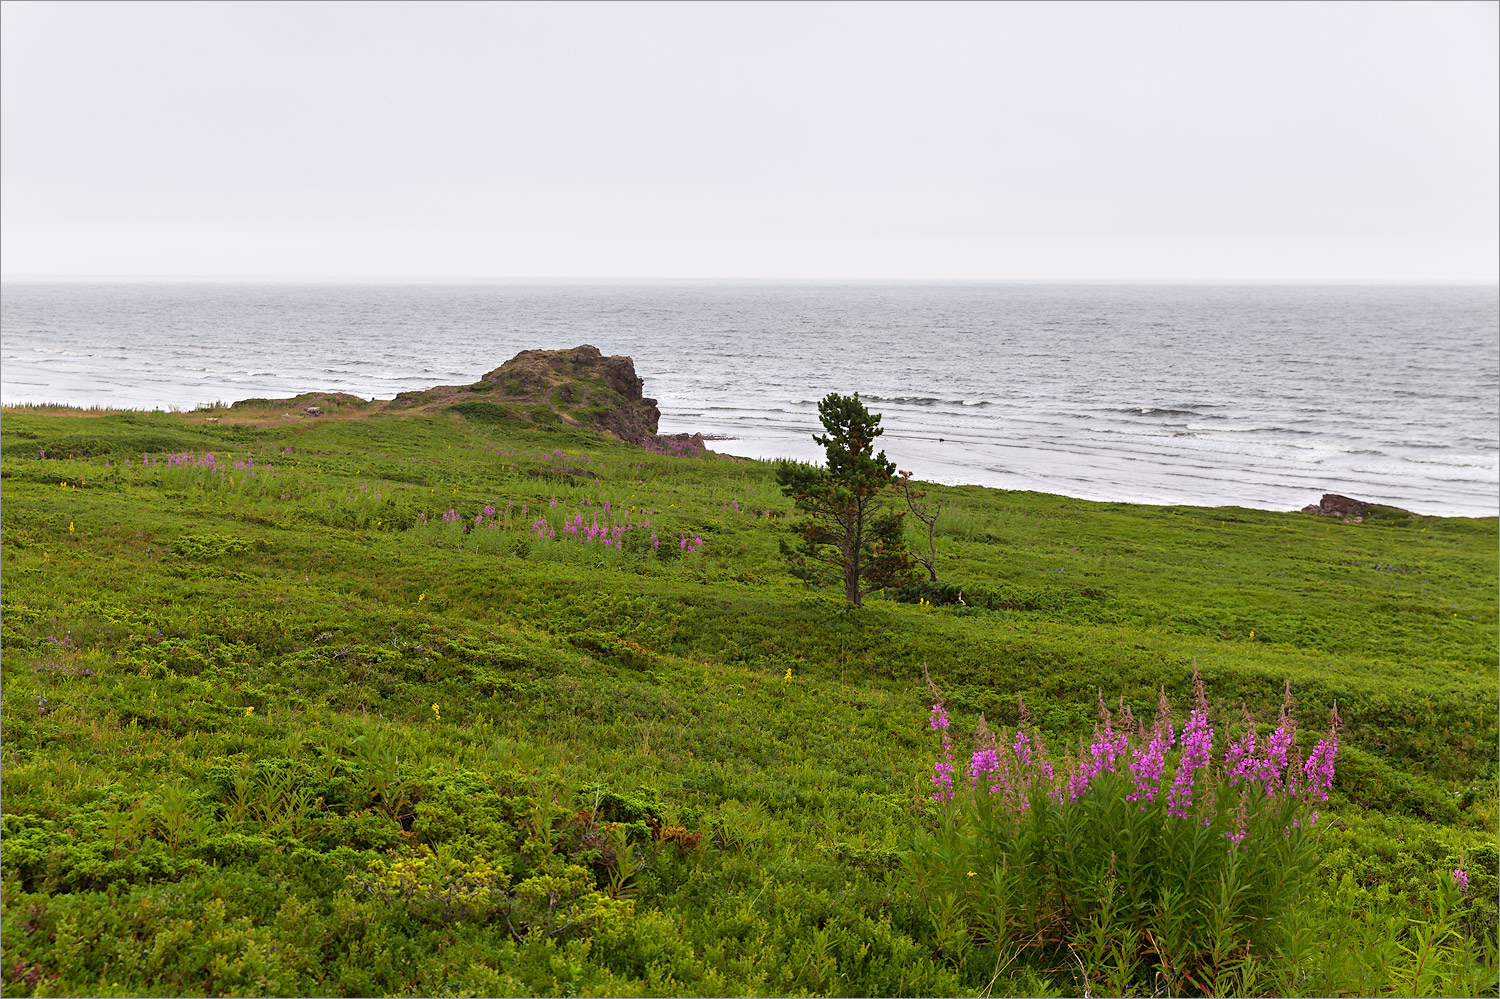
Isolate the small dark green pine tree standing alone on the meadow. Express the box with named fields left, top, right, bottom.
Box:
left=776, top=393, right=912, bottom=608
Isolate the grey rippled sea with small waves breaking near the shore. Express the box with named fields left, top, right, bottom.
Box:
left=0, top=277, right=1500, bottom=516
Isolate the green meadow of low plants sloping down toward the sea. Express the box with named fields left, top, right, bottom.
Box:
left=0, top=410, right=1500, bottom=996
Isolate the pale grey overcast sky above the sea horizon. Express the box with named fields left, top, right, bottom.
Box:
left=0, top=3, right=1500, bottom=282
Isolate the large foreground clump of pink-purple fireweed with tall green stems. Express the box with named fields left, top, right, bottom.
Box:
left=917, top=677, right=1340, bottom=995
